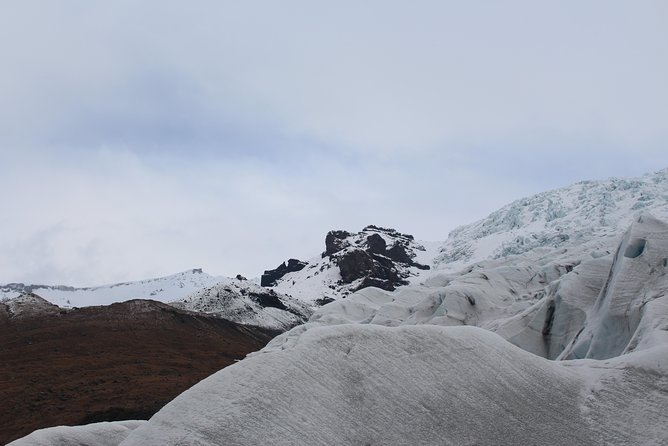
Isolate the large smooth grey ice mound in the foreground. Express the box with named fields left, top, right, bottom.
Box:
left=121, top=324, right=668, bottom=446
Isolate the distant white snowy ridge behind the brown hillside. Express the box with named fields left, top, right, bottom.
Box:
left=0, top=269, right=224, bottom=308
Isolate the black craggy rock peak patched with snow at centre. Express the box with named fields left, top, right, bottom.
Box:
left=265, top=225, right=433, bottom=305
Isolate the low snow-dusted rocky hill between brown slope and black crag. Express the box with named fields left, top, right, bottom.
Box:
left=169, top=279, right=313, bottom=331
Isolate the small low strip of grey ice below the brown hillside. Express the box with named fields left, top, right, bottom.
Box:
left=7, top=420, right=145, bottom=446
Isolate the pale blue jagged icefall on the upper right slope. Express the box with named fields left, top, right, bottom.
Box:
left=436, top=169, right=668, bottom=268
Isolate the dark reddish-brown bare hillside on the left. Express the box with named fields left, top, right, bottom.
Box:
left=0, top=296, right=276, bottom=444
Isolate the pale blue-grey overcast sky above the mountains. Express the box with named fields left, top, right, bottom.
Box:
left=0, top=0, right=668, bottom=286
